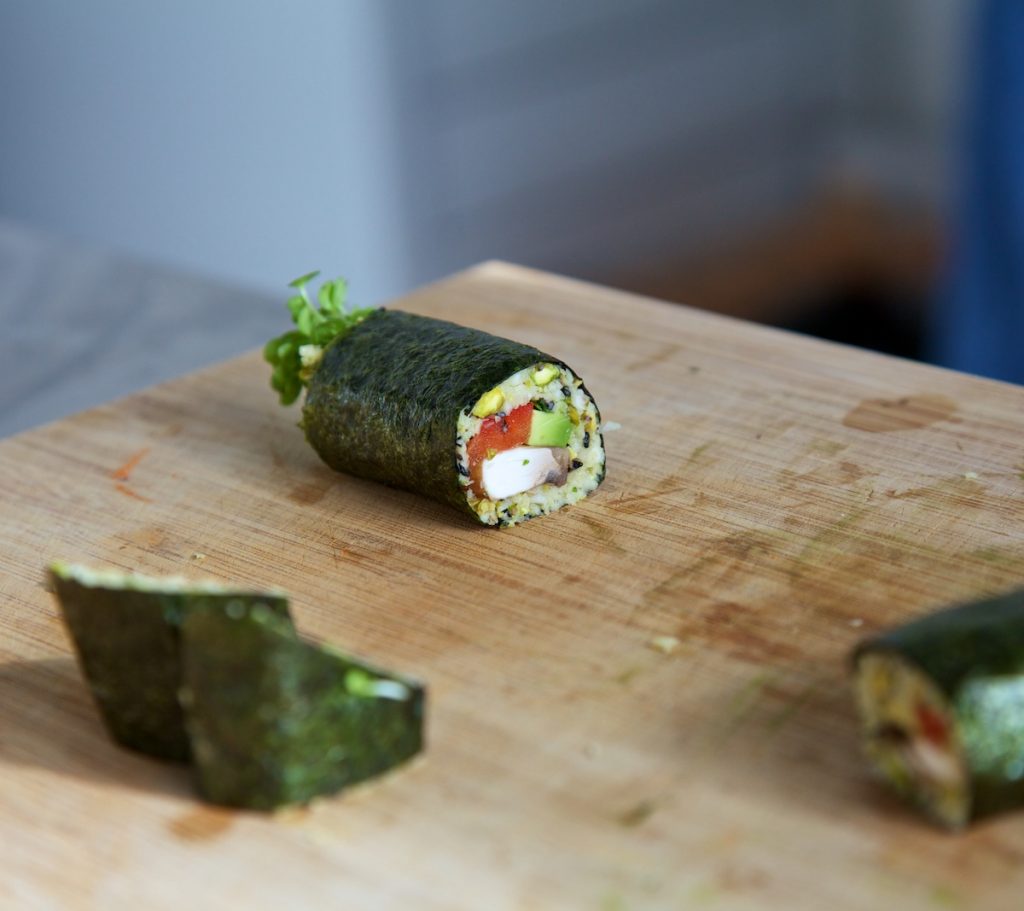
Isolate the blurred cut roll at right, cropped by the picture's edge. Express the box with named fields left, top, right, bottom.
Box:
left=854, top=590, right=1024, bottom=829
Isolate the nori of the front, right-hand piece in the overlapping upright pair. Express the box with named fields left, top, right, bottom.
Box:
left=181, top=608, right=424, bottom=810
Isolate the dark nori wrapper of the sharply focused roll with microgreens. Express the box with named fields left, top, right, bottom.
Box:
left=302, top=310, right=598, bottom=518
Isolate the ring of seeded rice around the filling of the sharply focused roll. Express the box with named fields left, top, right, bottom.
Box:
left=456, top=362, right=604, bottom=525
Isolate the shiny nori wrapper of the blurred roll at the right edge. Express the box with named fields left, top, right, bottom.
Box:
left=854, top=590, right=1024, bottom=818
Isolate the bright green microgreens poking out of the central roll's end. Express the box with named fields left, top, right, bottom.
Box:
left=263, top=271, right=373, bottom=405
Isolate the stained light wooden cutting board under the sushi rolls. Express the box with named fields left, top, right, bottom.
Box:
left=0, top=258, right=1024, bottom=911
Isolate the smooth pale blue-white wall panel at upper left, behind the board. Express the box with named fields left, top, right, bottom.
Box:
left=0, top=0, right=411, bottom=300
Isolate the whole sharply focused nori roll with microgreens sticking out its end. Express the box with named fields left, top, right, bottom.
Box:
left=264, top=276, right=604, bottom=525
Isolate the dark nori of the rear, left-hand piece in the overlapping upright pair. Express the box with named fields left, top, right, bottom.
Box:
left=50, top=570, right=291, bottom=762
